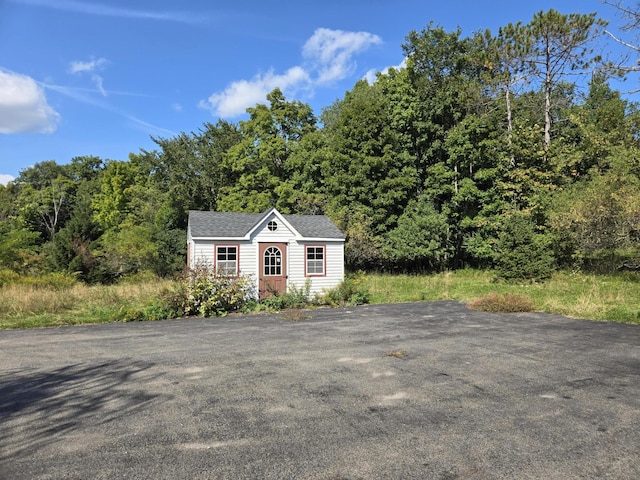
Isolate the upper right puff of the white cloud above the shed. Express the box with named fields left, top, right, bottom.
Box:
left=302, top=28, right=382, bottom=85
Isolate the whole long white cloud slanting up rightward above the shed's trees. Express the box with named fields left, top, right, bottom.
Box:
left=200, top=28, right=382, bottom=117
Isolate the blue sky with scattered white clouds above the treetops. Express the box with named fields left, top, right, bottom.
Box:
left=0, top=0, right=632, bottom=183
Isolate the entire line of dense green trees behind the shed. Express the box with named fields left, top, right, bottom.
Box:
left=0, top=10, right=640, bottom=282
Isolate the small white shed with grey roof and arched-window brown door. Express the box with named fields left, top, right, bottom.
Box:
left=187, top=208, right=344, bottom=298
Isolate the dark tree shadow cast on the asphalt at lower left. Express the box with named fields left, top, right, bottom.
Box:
left=0, top=360, right=168, bottom=465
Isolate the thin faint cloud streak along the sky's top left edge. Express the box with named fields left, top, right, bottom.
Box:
left=9, top=0, right=206, bottom=23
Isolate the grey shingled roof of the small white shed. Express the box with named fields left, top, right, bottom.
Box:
left=189, top=209, right=344, bottom=240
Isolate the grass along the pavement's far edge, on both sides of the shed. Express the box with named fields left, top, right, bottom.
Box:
left=0, top=270, right=640, bottom=329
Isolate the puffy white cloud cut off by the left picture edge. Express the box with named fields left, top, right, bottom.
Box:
left=0, top=70, right=60, bottom=133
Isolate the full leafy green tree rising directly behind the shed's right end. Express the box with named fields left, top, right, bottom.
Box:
left=321, top=80, right=418, bottom=236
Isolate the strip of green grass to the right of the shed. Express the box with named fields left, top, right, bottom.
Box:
left=366, top=270, right=640, bottom=324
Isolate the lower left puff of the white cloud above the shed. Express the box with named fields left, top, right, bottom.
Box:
left=200, top=67, right=309, bottom=117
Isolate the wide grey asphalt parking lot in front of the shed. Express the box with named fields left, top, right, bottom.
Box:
left=0, top=302, right=640, bottom=480
